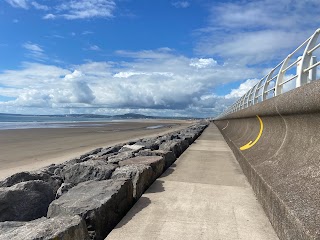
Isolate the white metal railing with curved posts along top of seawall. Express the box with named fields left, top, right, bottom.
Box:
left=216, top=28, right=320, bottom=119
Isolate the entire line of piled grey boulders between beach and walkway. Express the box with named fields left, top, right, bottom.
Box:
left=0, top=123, right=207, bottom=240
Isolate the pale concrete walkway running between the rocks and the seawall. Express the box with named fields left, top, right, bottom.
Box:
left=107, top=124, right=278, bottom=240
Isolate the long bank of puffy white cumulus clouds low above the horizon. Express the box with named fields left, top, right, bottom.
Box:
left=0, top=51, right=256, bottom=116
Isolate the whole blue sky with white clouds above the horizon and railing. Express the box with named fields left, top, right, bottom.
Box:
left=0, top=0, right=320, bottom=117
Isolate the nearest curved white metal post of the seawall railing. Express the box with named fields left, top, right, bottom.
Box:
left=296, top=29, right=320, bottom=87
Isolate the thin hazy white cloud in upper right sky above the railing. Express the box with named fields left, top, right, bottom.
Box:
left=196, top=0, right=318, bottom=65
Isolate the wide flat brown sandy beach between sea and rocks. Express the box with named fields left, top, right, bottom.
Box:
left=0, top=120, right=192, bottom=180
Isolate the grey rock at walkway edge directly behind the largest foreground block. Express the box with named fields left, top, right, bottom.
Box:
left=111, top=164, right=153, bottom=200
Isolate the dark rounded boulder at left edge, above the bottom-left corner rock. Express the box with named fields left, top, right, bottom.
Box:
left=0, top=180, right=55, bottom=222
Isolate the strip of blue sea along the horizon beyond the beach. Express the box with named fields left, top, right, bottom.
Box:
left=0, top=114, right=114, bottom=130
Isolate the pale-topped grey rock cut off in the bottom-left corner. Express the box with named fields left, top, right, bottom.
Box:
left=0, top=215, right=89, bottom=240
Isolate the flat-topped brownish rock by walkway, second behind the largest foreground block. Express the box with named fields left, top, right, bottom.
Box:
left=119, top=156, right=165, bottom=182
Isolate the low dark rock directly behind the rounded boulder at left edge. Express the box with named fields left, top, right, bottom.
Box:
left=0, top=171, right=62, bottom=192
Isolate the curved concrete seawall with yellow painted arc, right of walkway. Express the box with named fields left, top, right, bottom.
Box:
left=215, top=79, right=320, bottom=239
